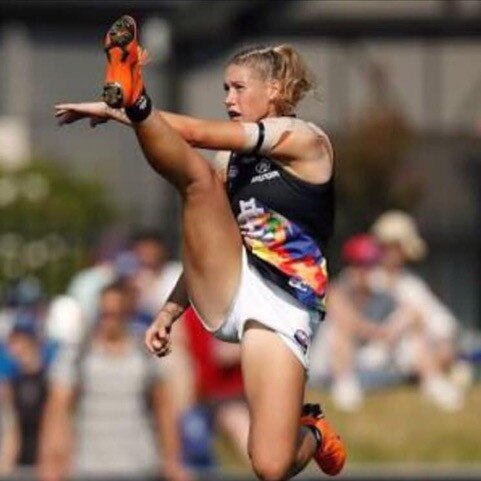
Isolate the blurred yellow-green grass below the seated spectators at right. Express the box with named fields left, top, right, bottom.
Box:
left=218, top=385, right=481, bottom=467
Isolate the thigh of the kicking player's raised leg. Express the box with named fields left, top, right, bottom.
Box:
left=182, top=167, right=242, bottom=329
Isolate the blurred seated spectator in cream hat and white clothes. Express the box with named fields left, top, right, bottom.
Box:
left=371, top=210, right=463, bottom=411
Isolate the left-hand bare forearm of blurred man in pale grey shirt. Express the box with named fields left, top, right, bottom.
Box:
left=38, top=384, right=74, bottom=481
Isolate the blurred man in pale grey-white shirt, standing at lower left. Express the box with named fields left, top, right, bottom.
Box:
left=39, top=282, right=191, bottom=481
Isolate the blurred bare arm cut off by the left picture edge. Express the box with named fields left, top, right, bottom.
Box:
left=0, top=383, right=21, bottom=477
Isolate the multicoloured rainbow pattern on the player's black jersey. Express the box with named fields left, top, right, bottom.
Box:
left=237, top=198, right=328, bottom=312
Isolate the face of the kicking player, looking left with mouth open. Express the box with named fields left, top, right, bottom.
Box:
left=224, top=65, right=276, bottom=122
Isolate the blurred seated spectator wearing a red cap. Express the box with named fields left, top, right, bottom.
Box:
left=312, top=234, right=410, bottom=411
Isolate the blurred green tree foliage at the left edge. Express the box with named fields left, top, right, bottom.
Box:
left=0, top=161, right=115, bottom=300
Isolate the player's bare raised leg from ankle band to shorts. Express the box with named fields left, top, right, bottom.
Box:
left=135, top=113, right=242, bottom=328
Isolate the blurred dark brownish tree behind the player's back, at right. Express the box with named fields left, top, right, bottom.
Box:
left=332, top=64, right=424, bottom=270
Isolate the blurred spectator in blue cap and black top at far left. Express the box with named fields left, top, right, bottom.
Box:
left=0, top=311, right=55, bottom=475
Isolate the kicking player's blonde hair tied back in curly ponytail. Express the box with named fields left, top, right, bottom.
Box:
left=229, top=44, right=314, bottom=115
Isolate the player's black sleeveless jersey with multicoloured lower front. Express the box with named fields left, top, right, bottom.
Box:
left=226, top=141, right=334, bottom=314
